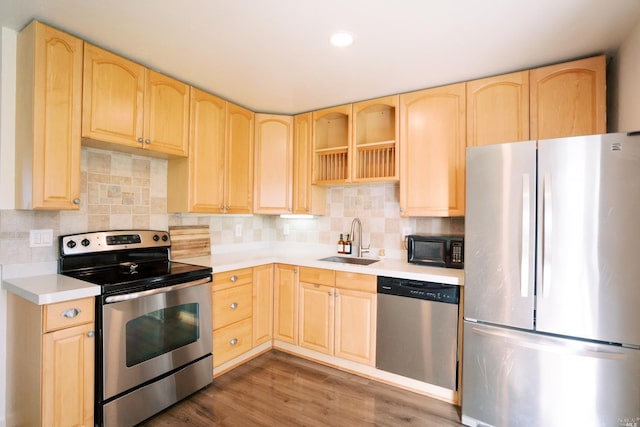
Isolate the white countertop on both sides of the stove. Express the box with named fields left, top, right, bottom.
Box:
left=2, top=247, right=464, bottom=305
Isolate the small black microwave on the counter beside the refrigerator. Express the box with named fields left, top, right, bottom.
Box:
left=407, top=234, right=464, bottom=268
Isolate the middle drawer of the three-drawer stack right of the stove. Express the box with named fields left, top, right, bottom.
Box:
left=213, top=283, right=253, bottom=330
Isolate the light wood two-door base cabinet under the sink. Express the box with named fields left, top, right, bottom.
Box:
left=299, top=267, right=377, bottom=366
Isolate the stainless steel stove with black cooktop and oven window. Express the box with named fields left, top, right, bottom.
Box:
left=59, top=230, right=213, bottom=426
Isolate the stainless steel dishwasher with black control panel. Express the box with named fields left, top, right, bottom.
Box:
left=376, top=276, right=460, bottom=390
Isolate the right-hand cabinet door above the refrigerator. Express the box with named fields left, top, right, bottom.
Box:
left=531, top=56, right=607, bottom=139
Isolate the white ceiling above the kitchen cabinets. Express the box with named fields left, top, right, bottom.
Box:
left=0, top=0, right=640, bottom=114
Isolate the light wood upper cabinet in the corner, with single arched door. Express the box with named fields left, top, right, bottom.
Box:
left=253, top=114, right=293, bottom=214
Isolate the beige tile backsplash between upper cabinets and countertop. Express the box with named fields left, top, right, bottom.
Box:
left=0, top=147, right=464, bottom=264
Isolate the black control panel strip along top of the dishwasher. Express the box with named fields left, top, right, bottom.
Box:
left=378, top=276, right=460, bottom=304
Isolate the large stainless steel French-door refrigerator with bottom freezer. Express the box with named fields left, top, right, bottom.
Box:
left=462, top=134, right=640, bottom=427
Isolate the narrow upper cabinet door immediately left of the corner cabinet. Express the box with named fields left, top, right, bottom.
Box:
left=225, top=102, right=253, bottom=214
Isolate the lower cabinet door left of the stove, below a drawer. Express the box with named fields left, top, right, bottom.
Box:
left=41, top=323, right=95, bottom=427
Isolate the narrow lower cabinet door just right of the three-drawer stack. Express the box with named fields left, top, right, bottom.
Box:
left=253, top=264, right=273, bottom=347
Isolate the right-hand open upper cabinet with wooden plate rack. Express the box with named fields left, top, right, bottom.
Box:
left=350, top=95, right=399, bottom=182
